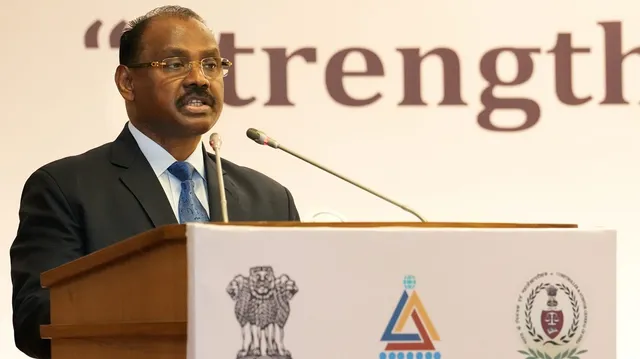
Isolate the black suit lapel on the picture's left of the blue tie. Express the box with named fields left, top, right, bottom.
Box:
left=111, top=125, right=178, bottom=227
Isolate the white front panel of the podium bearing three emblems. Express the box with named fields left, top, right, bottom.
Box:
left=187, top=225, right=616, bottom=359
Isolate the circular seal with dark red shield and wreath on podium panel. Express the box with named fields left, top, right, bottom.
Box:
left=516, top=272, right=587, bottom=359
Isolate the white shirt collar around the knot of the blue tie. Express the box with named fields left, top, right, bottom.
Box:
left=128, top=122, right=205, bottom=179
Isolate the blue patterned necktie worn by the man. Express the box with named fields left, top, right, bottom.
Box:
left=167, top=162, right=209, bottom=223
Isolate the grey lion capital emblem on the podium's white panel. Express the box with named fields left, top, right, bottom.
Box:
left=227, top=266, right=298, bottom=359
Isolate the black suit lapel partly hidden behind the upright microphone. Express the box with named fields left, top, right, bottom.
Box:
left=203, top=148, right=243, bottom=222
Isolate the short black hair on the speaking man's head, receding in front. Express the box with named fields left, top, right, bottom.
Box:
left=119, top=5, right=206, bottom=66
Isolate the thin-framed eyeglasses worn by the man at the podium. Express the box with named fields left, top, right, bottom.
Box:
left=127, top=57, right=231, bottom=79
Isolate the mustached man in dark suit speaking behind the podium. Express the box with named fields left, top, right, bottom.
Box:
left=10, top=6, right=300, bottom=358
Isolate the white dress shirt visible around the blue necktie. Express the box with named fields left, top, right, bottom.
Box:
left=128, top=122, right=211, bottom=220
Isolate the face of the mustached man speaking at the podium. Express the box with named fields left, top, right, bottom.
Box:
left=126, top=17, right=224, bottom=138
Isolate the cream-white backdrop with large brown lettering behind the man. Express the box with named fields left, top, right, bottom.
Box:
left=0, top=0, right=640, bottom=359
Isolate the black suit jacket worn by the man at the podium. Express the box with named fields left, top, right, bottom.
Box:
left=10, top=126, right=300, bottom=358
